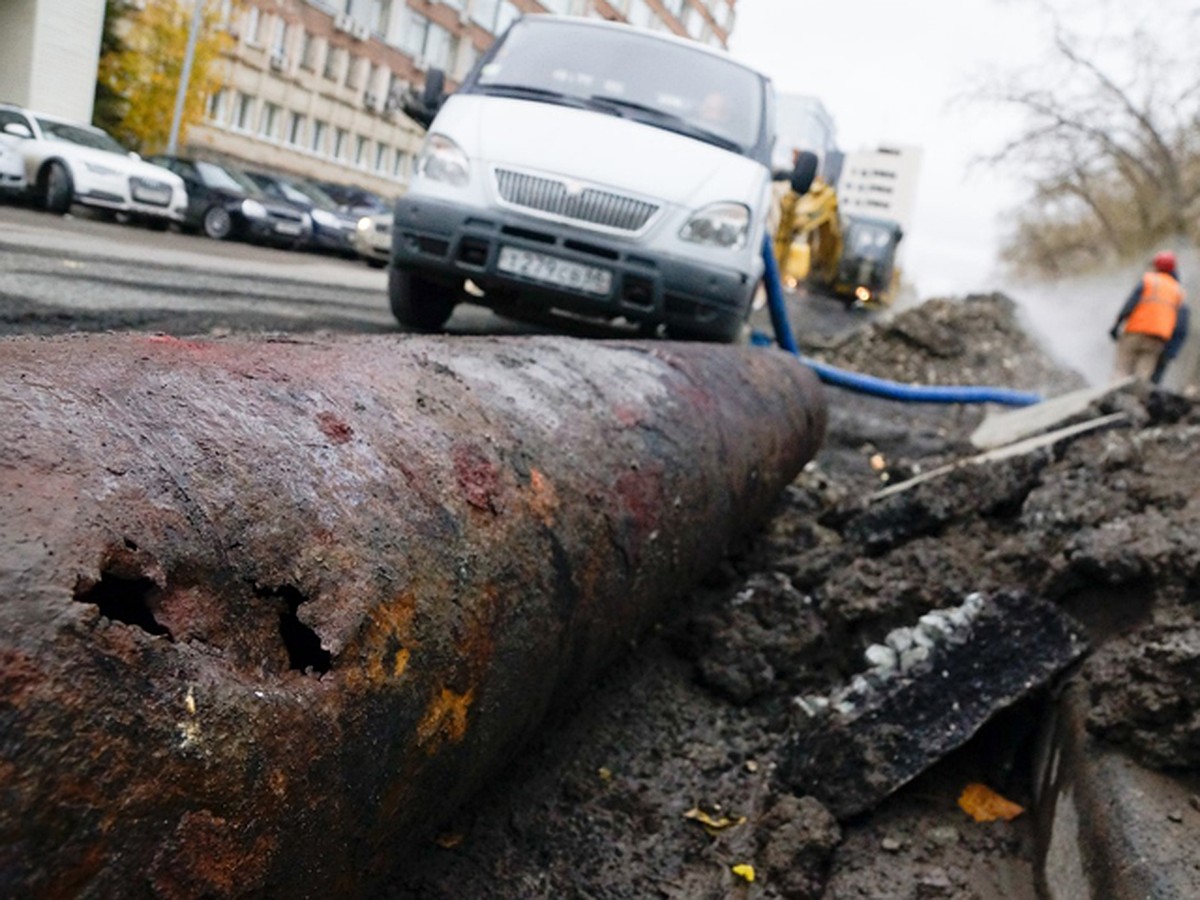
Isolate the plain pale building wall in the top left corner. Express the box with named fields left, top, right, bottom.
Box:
left=0, top=0, right=104, bottom=122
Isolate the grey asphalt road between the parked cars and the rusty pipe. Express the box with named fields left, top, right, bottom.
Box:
left=0, top=204, right=566, bottom=336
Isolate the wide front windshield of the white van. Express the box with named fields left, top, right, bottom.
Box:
left=467, top=20, right=766, bottom=151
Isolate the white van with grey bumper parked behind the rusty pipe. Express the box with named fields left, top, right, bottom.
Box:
left=389, top=16, right=815, bottom=342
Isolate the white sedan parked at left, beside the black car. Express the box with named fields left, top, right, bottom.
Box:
left=0, top=103, right=187, bottom=227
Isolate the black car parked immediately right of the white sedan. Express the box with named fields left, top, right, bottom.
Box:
left=150, top=154, right=312, bottom=246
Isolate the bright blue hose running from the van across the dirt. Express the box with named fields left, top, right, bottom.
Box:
left=754, top=236, right=1042, bottom=407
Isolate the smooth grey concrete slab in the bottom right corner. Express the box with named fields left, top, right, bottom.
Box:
left=1034, top=679, right=1200, bottom=900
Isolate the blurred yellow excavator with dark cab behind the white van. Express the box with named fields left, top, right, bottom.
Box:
left=774, top=178, right=904, bottom=306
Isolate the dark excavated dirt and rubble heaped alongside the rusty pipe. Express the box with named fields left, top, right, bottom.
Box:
left=390, top=295, right=1200, bottom=900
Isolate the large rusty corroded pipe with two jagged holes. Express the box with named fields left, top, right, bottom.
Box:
left=0, top=335, right=824, bottom=898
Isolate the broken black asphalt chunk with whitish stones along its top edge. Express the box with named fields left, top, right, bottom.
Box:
left=784, top=592, right=1087, bottom=820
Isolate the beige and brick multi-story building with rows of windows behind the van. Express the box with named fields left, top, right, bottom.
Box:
left=194, top=0, right=737, bottom=197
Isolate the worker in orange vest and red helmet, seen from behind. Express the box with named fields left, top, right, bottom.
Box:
left=1109, top=251, right=1188, bottom=384
